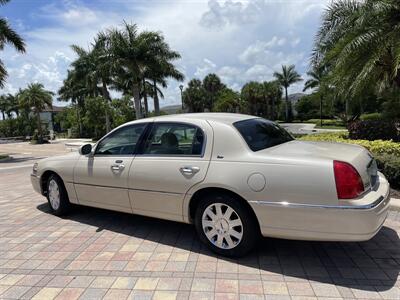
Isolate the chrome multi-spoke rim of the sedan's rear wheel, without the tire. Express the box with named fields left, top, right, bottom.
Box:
left=201, top=203, right=243, bottom=249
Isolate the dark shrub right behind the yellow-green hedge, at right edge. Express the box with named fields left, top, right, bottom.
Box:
left=348, top=120, right=400, bottom=141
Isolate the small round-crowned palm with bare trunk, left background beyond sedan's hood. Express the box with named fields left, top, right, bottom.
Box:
left=19, top=83, right=54, bottom=142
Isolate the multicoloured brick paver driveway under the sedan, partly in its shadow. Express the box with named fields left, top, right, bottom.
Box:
left=0, top=159, right=400, bottom=300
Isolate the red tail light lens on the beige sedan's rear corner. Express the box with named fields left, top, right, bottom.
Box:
left=333, top=160, right=364, bottom=199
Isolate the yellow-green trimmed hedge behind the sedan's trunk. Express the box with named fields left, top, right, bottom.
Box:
left=299, top=132, right=400, bottom=187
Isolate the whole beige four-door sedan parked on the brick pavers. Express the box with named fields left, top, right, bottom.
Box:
left=31, top=113, right=389, bottom=256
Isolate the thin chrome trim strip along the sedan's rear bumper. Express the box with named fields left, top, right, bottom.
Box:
left=249, top=195, right=390, bottom=210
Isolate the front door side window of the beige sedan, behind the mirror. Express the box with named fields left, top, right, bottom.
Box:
left=95, top=123, right=147, bottom=155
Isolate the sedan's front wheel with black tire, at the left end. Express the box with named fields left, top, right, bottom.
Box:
left=47, top=174, right=71, bottom=216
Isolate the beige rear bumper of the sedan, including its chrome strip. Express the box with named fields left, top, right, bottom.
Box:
left=249, top=174, right=390, bottom=241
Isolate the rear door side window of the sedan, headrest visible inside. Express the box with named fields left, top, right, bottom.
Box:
left=143, top=123, right=204, bottom=156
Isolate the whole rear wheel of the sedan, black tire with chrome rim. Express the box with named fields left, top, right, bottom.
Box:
left=194, top=194, right=260, bottom=257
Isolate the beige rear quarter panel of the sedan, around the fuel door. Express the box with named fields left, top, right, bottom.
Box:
left=184, top=122, right=338, bottom=225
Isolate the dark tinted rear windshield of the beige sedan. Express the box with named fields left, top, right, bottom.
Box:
left=233, top=119, right=294, bottom=151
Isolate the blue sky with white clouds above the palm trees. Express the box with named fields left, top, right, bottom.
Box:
left=0, top=0, right=329, bottom=106
